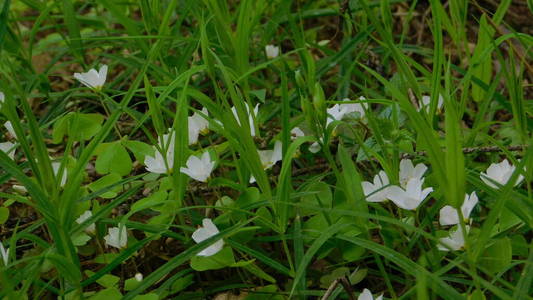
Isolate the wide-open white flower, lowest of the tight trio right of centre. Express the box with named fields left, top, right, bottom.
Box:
left=387, top=178, right=433, bottom=210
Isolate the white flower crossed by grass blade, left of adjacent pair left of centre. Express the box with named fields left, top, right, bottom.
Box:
left=144, top=131, right=175, bottom=174
